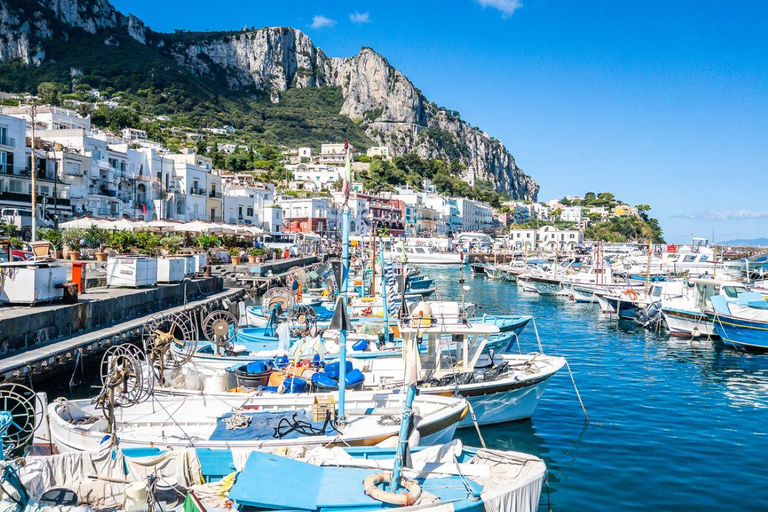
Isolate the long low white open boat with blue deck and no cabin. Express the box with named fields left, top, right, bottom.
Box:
left=47, top=390, right=467, bottom=452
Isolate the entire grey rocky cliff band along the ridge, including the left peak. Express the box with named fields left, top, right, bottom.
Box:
left=0, top=0, right=539, bottom=199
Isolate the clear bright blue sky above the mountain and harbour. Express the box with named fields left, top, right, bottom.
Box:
left=114, top=0, right=768, bottom=242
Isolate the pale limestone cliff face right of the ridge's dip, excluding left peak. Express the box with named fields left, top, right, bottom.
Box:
left=171, top=31, right=539, bottom=200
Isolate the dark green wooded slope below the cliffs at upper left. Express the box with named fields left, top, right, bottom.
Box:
left=0, top=23, right=372, bottom=147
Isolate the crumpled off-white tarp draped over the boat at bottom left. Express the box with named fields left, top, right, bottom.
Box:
left=14, top=445, right=203, bottom=509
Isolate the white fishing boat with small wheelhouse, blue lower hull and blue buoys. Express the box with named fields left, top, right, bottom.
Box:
left=155, top=316, right=565, bottom=427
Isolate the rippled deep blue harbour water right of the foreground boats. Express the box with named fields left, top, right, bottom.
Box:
left=424, top=267, right=768, bottom=511
